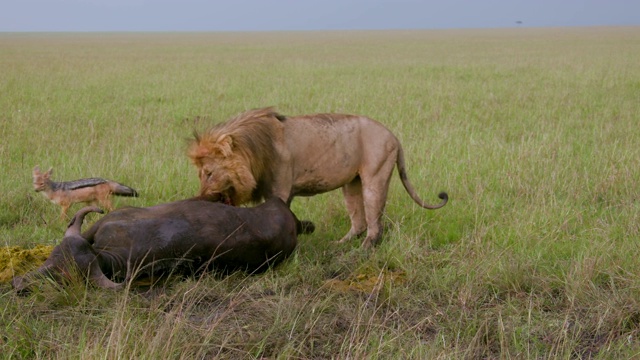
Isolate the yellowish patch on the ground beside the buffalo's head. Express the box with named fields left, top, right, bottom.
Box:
left=0, top=245, right=53, bottom=284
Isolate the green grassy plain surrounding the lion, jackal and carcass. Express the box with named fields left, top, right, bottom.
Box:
left=0, top=27, right=640, bottom=359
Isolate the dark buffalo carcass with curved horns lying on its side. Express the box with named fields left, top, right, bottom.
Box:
left=12, top=198, right=302, bottom=292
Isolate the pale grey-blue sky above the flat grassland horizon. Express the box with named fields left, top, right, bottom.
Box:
left=0, top=0, right=640, bottom=32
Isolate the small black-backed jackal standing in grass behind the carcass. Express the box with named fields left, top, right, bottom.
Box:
left=33, top=165, right=138, bottom=219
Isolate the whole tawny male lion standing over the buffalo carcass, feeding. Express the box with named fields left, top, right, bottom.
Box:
left=188, top=107, right=448, bottom=247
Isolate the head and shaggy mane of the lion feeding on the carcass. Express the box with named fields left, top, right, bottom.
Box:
left=188, top=108, right=284, bottom=205
